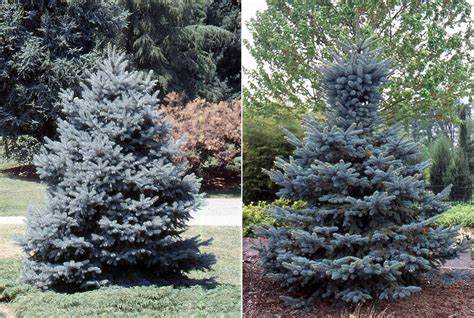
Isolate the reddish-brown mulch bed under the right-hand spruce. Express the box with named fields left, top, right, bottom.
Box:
left=243, top=238, right=474, bottom=318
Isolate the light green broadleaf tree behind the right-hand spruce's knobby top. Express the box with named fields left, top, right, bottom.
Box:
left=244, top=0, right=474, bottom=123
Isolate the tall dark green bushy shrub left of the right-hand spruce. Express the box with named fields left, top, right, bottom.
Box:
left=242, top=114, right=302, bottom=204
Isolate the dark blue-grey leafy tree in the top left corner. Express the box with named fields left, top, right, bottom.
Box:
left=0, top=0, right=126, bottom=160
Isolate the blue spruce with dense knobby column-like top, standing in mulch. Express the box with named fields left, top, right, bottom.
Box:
left=258, top=40, right=466, bottom=306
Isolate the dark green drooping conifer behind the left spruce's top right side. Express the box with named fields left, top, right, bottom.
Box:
left=121, top=0, right=240, bottom=101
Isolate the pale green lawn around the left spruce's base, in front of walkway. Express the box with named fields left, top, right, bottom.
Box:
left=0, top=225, right=241, bottom=317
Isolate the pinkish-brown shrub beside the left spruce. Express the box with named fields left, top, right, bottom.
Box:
left=163, top=93, right=241, bottom=175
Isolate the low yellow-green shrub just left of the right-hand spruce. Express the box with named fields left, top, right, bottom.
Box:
left=242, top=199, right=304, bottom=237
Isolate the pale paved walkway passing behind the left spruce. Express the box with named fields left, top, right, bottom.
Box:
left=0, top=198, right=242, bottom=226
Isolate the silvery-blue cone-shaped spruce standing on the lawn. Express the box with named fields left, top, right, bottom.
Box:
left=20, top=48, right=214, bottom=289
